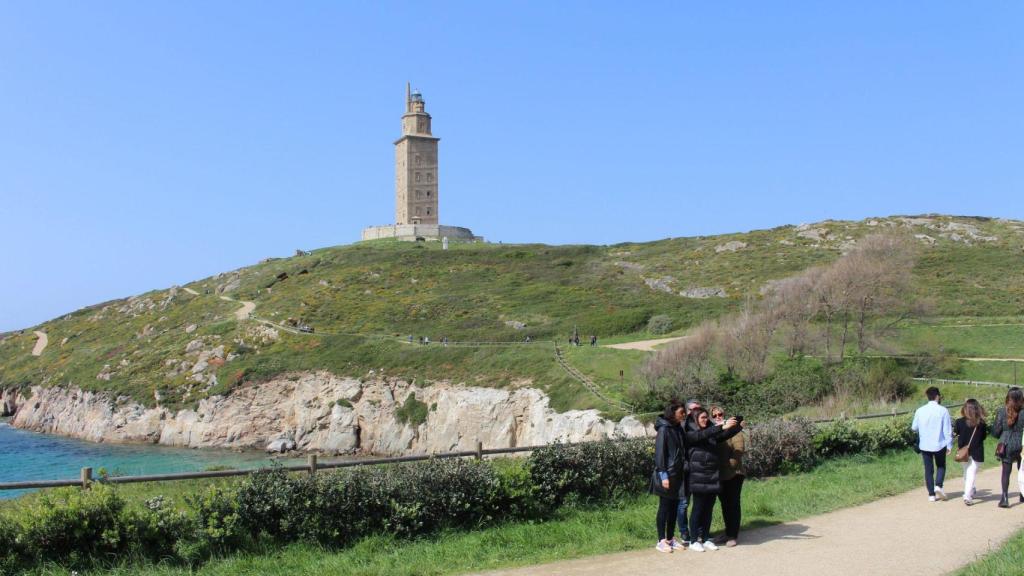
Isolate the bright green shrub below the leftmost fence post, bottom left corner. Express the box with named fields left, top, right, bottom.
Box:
left=22, top=484, right=136, bottom=566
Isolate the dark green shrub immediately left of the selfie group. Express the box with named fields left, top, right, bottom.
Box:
left=529, top=439, right=653, bottom=509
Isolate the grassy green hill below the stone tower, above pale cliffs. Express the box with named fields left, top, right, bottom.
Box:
left=0, top=216, right=1024, bottom=409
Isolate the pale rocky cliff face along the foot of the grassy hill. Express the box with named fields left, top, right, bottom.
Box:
left=12, top=372, right=649, bottom=455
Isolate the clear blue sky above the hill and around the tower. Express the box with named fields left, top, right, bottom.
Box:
left=0, top=0, right=1024, bottom=330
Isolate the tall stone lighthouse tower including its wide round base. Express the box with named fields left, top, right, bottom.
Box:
left=362, top=84, right=483, bottom=241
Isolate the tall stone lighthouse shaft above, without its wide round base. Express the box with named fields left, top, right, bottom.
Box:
left=394, top=84, right=440, bottom=224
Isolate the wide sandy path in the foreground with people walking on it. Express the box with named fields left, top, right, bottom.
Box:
left=477, top=467, right=1024, bottom=576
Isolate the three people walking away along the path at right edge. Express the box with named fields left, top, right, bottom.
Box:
left=910, top=386, right=1024, bottom=508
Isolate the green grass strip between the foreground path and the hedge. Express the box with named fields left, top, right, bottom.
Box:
left=34, top=451, right=991, bottom=576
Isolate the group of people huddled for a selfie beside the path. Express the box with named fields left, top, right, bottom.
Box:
left=650, top=400, right=744, bottom=552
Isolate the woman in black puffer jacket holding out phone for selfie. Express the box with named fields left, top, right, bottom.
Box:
left=683, top=408, right=742, bottom=552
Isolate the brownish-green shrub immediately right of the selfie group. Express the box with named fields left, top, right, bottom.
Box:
left=743, top=418, right=815, bottom=478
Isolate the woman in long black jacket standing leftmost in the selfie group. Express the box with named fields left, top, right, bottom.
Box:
left=650, top=402, right=686, bottom=552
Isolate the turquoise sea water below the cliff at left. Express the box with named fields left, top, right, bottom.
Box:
left=0, top=419, right=301, bottom=499
